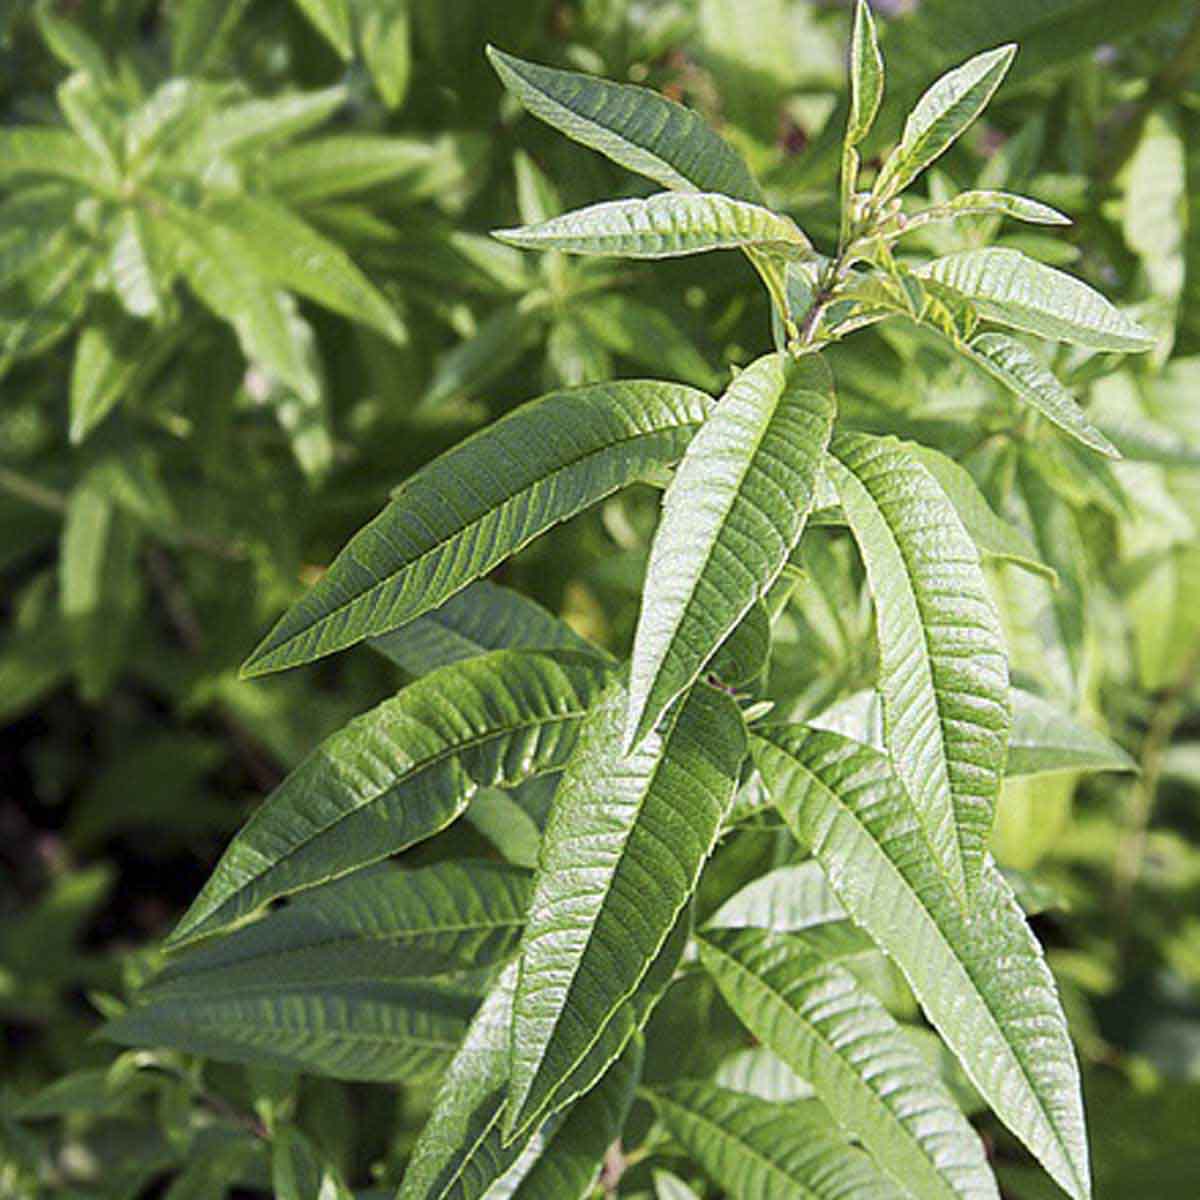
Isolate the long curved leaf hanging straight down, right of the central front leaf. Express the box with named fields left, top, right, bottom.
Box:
left=829, top=434, right=1009, bottom=901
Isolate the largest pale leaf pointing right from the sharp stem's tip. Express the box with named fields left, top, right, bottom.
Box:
left=917, top=246, right=1154, bottom=352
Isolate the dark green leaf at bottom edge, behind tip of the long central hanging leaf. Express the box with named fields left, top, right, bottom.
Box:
left=512, top=1038, right=642, bottom=1200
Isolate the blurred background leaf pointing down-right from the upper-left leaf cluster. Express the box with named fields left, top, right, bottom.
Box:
left=205, top=196, right=406, bottom=343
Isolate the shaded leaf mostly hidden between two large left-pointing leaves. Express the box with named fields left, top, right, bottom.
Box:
left=370, top=580, right=608, bottom=676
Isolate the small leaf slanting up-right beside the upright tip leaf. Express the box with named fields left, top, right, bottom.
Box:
left=875, top=46, right=1016, bottom=200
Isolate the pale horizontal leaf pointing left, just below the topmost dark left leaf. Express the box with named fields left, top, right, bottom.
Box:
left=494, top=192, right=814, bottom=258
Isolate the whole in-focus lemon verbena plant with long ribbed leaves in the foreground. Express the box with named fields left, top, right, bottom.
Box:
left=108, top=0, right=1151, bottom=1200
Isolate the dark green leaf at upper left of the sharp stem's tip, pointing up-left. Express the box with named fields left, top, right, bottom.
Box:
left=487, top=46, right=762, bottom=204
